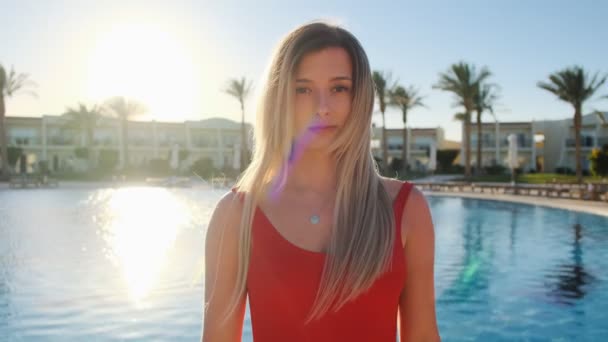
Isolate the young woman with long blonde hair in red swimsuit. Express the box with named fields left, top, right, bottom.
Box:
left=203, top=22, right=439, bottom=342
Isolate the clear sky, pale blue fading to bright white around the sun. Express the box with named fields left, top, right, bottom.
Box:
left=0, top=0, right=608, bottom=141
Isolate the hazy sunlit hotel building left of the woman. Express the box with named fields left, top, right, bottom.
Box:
left=0, top=115, right=251, bottom=171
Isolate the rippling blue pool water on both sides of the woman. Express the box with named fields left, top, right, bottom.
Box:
left=0, top=185, right=608, bottom=341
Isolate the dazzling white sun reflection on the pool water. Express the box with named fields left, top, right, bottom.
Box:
left=98, top=188, right=188, bottom=304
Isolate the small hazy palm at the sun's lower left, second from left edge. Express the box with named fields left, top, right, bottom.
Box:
left=63, top=103, right=102, bottom=167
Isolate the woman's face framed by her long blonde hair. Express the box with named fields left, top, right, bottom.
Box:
left=292, top=47, right=353, bottom=149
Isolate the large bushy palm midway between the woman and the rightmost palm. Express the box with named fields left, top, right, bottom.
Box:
left=433, top=62, right=491, bottom=178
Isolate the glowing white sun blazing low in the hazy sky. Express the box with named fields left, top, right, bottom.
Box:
left=87, top=24, right=201, bottom=121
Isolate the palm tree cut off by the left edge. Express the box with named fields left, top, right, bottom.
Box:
left=0, top=64, right=36, bottom=177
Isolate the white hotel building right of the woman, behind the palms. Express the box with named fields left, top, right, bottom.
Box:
left=372, top=112, right=608, bottom=173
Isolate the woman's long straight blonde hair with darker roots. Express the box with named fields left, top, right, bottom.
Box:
left=221, top=22, right=395, bottom=321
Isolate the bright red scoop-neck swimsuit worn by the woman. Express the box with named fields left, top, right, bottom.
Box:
left=247, top=182, right=412, bottom=342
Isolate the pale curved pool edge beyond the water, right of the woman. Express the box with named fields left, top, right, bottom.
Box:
left=422, top=190, right=608, bottom=217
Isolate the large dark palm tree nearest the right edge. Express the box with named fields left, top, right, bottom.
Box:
left=536, top=66, right=608, bottom=183
